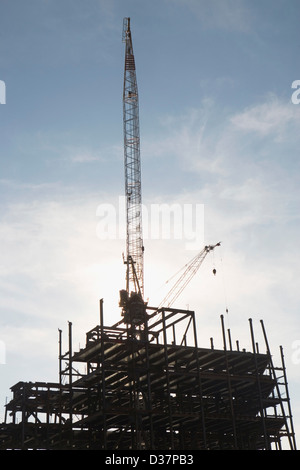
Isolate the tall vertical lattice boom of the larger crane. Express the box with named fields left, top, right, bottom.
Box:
left=123, top=18, right=144, bottom=297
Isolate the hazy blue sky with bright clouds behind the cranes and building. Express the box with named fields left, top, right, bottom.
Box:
left=0, top=0, right=300, bottom=448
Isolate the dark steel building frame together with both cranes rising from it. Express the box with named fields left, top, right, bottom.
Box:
left=0, top=18, right=296, bottom=450
